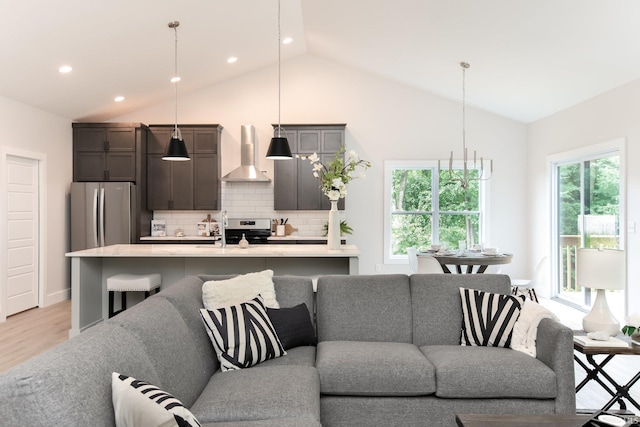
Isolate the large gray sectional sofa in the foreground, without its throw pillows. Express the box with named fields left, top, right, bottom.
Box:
left=0, top=274, right=575, bottom=427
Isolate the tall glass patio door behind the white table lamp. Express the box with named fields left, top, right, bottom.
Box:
left=551, top=141, right=625, bottom=308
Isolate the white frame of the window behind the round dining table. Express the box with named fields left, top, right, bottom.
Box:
left=383, top=159, right=491, bottom=264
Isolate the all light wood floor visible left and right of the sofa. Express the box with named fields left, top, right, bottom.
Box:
left=0, top=300, right=640, bottom=414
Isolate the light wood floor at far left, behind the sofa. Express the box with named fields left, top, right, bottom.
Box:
left=0, top=300, right=71, bottom=372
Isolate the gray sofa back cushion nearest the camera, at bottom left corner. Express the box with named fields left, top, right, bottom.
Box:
left=0, top=323, right=159, bottom=426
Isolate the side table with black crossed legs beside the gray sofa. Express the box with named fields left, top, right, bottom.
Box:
left=573, top=331, right=640, bottom=411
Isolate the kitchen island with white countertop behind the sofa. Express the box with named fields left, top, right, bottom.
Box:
left=66, top=242, right=360, bottom=337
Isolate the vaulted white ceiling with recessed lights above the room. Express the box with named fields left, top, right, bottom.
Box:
left=5, top=0, right=640, bottom=123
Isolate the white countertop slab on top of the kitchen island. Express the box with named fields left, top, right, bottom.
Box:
left=65, top=243, right=360, bottom=258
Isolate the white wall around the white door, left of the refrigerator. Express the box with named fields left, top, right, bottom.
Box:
left=0, top=97, right=73, bottom=306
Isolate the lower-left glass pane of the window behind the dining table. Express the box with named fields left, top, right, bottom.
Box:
left=391, top=214, right=431, bottom=255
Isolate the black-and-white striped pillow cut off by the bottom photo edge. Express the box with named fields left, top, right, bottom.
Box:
left=111, top=372, right=200, bottom=427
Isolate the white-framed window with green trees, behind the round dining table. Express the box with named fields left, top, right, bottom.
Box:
left=384, top=160, right=487, bottom=263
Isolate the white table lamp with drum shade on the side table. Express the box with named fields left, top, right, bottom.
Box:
left=576, top=248, right=626, bottom=336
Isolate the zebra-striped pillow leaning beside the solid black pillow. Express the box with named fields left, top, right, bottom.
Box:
left=200, top=295, right=287, bottom=371
